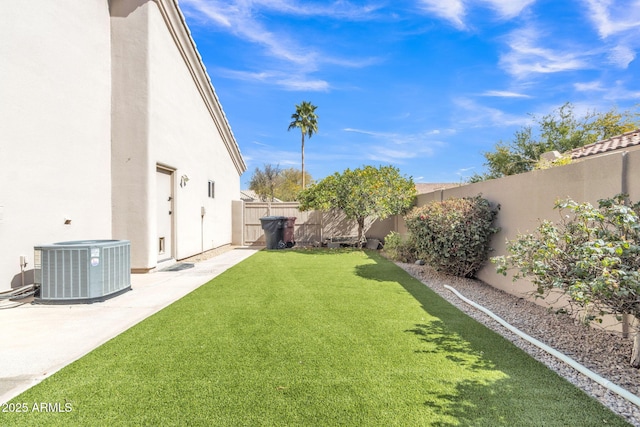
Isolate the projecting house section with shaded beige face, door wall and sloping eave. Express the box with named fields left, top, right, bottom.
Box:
left=111, top=0, right=246, bottom=270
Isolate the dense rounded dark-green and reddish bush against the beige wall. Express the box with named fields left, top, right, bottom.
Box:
left=405, top=195, right=499, bottom=277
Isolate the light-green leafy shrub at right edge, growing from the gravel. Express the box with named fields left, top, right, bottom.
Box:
left=492, top=195, right=640, bottom=368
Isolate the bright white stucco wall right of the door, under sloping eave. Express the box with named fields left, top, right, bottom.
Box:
left=149, top=4, right=240, bottom=259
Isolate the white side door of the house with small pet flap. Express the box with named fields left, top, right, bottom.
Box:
left=156, top=167, right=174, bottom=262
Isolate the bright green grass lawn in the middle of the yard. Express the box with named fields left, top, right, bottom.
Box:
left=0, top=250, right=627, bottom=427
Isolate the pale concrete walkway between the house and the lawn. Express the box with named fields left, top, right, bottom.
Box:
left=0, top=248, right=258, bottom=403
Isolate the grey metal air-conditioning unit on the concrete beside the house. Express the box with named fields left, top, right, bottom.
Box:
left=34, top=240, right=131, bottom=304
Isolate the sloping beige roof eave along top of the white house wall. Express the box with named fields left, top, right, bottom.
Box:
left=156, top=0, right=247, bottom=174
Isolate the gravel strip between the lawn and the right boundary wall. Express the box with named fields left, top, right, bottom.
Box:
left=397, top=263, right=640, bottom=427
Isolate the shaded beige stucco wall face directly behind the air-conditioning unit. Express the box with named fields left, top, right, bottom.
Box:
left=111, top=0, right=156, bottom=268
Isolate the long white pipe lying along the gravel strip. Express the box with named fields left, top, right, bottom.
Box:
left=444, top=285, right=640, bottom=407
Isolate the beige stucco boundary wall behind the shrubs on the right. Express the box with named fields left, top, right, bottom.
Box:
left=398, top=150, right=640, bottom=334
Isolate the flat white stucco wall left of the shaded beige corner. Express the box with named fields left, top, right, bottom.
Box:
left=0, top=0, right=111, bottom=290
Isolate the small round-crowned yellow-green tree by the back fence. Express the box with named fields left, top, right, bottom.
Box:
left=298, top=166, right=416, bottom=247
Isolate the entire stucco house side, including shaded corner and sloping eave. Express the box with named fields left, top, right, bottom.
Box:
left=0, top=0, right=246, bottom=290
